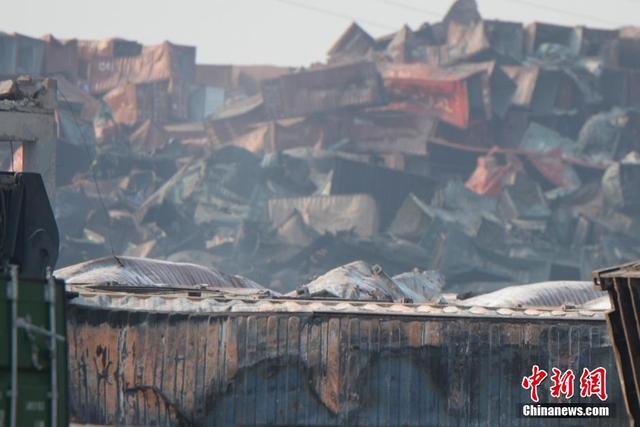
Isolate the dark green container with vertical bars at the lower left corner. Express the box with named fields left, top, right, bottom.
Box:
left=0, top=270, right=69, bottom=427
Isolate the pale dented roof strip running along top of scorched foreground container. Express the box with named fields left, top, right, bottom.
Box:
left=68, top=284, right=604, bottom=320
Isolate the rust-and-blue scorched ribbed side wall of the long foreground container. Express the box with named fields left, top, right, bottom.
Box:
left=67, top=306, right=627, bottom=426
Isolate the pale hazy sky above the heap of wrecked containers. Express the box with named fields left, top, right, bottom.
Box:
left=5, top=0, right=640, bottom=65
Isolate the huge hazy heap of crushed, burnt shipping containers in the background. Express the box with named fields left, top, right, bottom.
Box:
left=0, top=0, right=640, bottom=292
